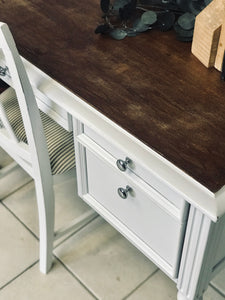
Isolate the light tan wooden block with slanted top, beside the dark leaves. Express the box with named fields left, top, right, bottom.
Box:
left=191, top=0, right=225, bottom=68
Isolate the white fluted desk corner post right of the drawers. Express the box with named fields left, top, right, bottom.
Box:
left=177, top=207, right=218, bottom=300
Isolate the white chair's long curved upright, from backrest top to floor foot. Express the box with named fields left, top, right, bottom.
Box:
left=0, top=23, right=54, bottom=273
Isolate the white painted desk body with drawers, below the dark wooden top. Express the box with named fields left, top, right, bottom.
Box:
left=2, top=53, right=225, bottom=300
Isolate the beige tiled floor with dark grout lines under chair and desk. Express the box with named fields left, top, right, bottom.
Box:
left=0, top=150, right=225, bottom=300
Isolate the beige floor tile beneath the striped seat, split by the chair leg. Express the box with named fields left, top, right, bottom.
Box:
left=4, top=171, right=89, bottom=236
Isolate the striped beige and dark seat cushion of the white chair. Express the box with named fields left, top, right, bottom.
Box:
left=0, top=87, right=75, bottom=174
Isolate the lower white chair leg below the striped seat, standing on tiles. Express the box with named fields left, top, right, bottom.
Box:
left=35, top=180, right=55, bottom=274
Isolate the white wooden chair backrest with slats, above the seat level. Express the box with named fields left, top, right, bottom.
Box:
left=0, top=22, right=51, bottom=180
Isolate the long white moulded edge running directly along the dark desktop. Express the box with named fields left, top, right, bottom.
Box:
left=4, top=56, right=220, bottom=221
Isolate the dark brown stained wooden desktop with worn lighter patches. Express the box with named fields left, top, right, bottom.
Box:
left=0, top=0, right=225, bottom=192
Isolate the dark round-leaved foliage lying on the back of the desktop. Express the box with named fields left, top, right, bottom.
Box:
left=95, top=0, right=211, bottom=41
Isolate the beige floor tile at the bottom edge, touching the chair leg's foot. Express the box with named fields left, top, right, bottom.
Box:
left=0, top=262, right=94, bottom=300
